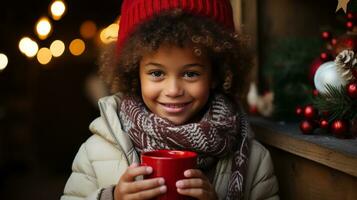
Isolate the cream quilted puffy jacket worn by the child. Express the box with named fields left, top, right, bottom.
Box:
left=61, top=96, right=279, bottom=200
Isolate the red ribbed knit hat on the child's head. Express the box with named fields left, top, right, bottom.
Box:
left=117, top=0, right=234, bottom=53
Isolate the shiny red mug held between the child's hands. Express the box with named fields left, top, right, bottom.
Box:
left=141, top=150, right=197, bottom=200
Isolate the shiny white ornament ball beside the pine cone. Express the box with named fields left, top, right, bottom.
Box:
left=314, top=61, right=346, bottom=94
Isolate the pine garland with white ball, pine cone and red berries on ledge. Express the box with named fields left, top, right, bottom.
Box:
left=296, top=50, right=357, bottom=138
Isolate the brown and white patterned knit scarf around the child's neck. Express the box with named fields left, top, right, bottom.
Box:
left=118, top=94, right=249, bottom=199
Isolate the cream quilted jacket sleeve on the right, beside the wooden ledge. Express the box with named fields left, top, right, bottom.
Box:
left=246, top=141, right=279, bottom=200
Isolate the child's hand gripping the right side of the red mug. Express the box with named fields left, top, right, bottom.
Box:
left=176, top=169, right=218, bottom=200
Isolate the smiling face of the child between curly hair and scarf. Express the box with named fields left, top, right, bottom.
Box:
left=140, top=45, right=212, bottom=125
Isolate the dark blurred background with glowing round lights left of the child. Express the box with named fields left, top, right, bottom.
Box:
left=0, top=0, right=121, bottom=199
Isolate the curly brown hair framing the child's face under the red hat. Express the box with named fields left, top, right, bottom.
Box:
left=99, top=10, right=251, bottom=103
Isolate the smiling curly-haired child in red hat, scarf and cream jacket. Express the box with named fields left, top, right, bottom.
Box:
left=61, top=0, right=279, bottom=200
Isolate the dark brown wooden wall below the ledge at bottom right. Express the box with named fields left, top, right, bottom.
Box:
left=269, top=147, right=357, bottom=200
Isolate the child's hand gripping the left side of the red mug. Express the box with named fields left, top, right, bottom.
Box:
left=114, top=163, right=167, bottom=200
